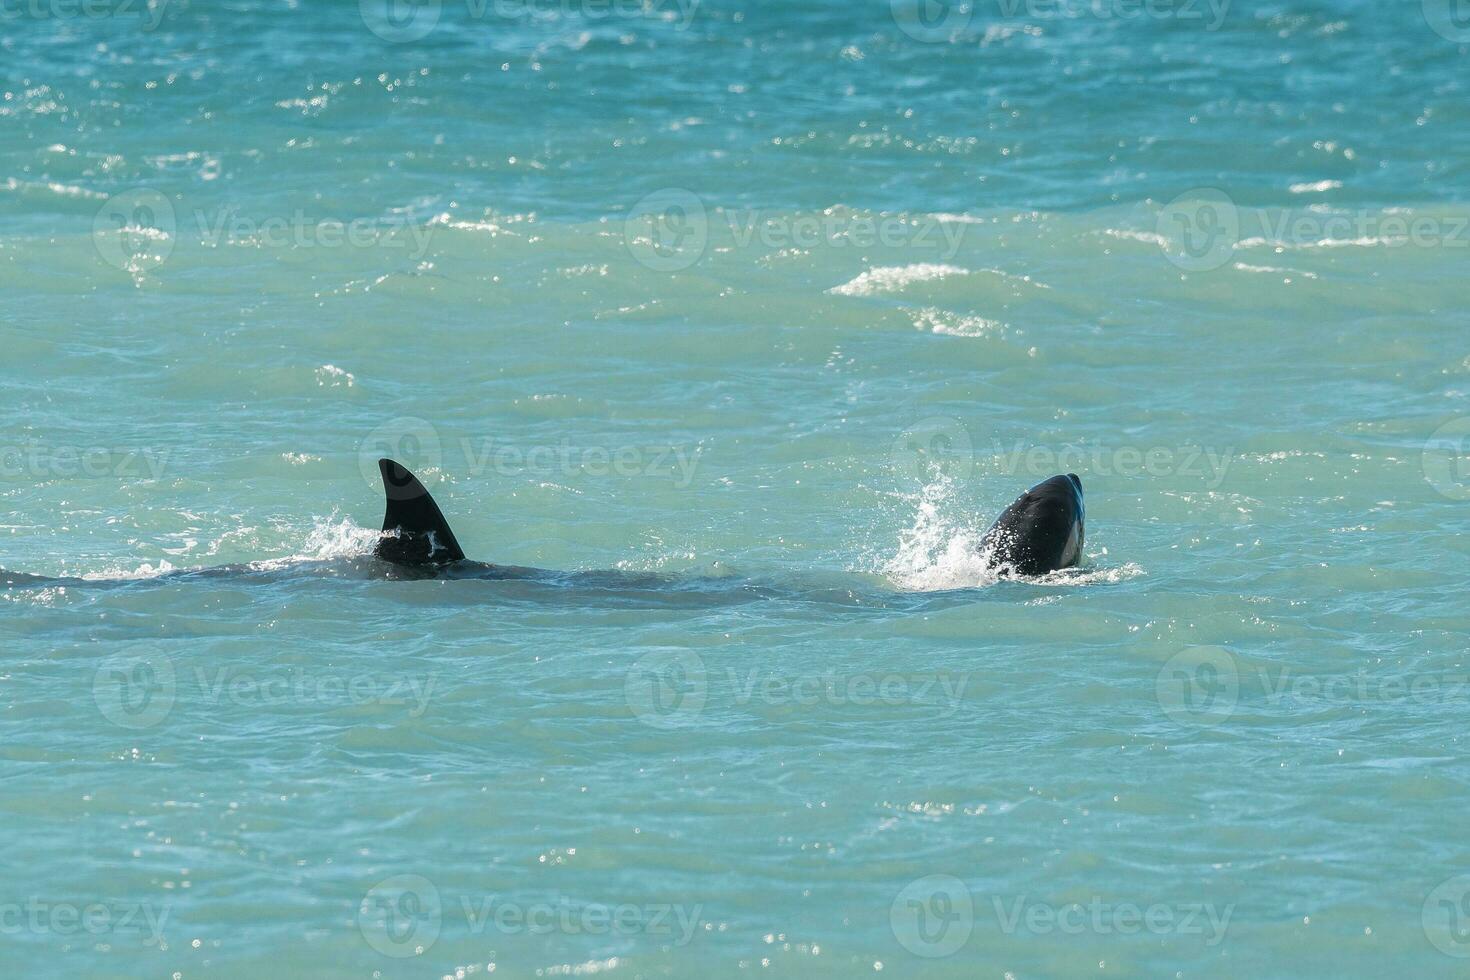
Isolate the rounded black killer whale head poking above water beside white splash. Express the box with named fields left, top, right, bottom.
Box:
left=980, top=473, right=1086, bottom=576
